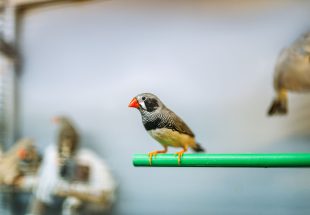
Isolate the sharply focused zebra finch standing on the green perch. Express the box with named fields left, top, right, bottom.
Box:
left=129, top=93, right=204, bottom=164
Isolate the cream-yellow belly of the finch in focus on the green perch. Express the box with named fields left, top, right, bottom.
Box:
left=148, top=128, right=195, bottom=147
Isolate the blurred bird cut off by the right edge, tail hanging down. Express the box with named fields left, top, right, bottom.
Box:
left=268, top=32, right=310, bottom=115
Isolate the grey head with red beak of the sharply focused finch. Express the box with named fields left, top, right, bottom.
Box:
left=128, top=93, right=164, bottom=112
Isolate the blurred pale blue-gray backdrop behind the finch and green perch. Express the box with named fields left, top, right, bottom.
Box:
left=19, top=1, right=310, bottom=215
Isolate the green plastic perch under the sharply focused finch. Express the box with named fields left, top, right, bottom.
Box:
left=133, top=153, right=310, bottom=167
